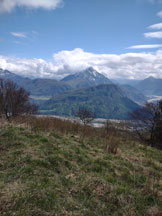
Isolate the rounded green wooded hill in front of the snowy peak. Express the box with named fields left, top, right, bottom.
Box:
left=40, top=84, right=139, bottom=119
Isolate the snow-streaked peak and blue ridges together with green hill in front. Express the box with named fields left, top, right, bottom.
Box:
left=0, top=67, right=152, bottom=119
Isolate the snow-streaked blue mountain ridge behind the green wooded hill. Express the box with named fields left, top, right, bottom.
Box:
left=0, top=67, right=146, bottom=104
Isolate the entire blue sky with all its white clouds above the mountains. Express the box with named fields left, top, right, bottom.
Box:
left=0, top=0, right=162, bottom=79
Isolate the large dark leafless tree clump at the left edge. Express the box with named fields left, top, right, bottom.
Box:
left=0, top=79, right=38, bottom=119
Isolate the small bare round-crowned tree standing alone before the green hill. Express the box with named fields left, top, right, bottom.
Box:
left=76, top=107, right=95, bottom=125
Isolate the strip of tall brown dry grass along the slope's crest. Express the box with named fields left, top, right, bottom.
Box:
left=13, top=117, right=127, bottom=154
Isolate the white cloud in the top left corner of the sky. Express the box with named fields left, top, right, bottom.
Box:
left=0, top=0, right=62, bottom=13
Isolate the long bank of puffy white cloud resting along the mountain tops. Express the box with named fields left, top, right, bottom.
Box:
left=0, top=48, right=162, bottom=79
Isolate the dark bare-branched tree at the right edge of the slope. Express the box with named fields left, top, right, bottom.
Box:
left=131, top=101, right=162, bottom=148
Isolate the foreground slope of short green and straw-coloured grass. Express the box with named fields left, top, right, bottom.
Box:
left=0, top=122, right=162, bottom=216
